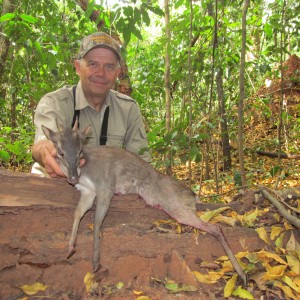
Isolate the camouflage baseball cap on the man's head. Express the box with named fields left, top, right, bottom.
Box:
left=78, top=32, right=121, bottom=60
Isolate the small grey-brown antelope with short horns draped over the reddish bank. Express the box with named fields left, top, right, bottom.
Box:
left=42, top=121, right=247, bottom=285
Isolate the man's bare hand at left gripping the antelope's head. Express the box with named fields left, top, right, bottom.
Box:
left=32, top=140, right=66, bottom=177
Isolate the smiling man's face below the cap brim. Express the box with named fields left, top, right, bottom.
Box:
left=75, top=48, right=120, bottom=102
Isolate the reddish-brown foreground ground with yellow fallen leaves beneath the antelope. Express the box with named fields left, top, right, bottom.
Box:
left=0, top=170, right=300, bottom=300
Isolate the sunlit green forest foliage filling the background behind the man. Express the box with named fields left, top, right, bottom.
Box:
left=0, top=0, right=299, bottom=178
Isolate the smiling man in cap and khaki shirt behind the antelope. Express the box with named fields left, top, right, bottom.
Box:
left=32, top=32, right=151, bottom=177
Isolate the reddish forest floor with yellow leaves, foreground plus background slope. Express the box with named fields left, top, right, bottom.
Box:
left=0, top=58, right=300, bottom=300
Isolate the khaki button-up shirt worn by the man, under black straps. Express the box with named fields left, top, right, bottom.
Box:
left=32, top=81, right=151, bottom=176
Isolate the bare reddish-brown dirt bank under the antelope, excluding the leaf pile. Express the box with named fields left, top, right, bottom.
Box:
left=0, top=170, right=263, bottom=300
